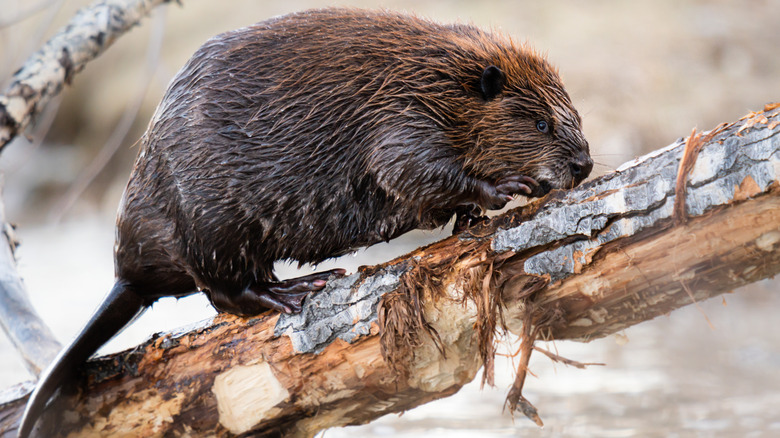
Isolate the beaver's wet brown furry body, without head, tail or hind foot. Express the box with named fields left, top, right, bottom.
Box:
left=118, top=9, right=580, bottom=294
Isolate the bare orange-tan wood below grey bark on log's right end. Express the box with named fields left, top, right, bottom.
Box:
left=524, top=189, right=780, bottom=340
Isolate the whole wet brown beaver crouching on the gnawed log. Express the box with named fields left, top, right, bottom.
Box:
left=19, top=9, right=593, bottom=437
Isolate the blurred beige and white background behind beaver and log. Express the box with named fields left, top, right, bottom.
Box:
left=0, top=0, right=780, bottom=437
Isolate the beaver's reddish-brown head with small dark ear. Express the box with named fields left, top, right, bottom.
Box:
left=458, top=48, right=593, bottom=196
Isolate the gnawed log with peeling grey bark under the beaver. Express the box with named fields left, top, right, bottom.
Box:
left=0, top=105, right=780, bottom=436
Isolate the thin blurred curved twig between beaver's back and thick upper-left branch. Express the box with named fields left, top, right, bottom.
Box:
left=50, top=10, right=166, bottom=222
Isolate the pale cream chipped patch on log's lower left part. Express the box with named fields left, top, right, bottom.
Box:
left=212, top=362, right=290, bottom=434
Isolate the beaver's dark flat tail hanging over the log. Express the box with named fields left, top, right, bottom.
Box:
left=18, top=281, right=148, bottom=438
